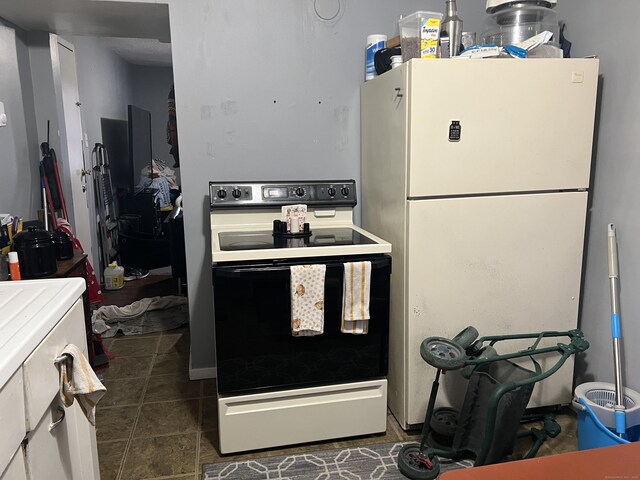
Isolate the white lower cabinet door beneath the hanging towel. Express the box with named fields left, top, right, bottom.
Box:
left=26, top=398, right=83, bottom=480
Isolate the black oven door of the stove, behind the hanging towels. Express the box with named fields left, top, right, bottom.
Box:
left=213, top=255, right=391, bottom=394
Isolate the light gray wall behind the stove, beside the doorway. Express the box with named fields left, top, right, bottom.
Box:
left=169, top=0, right=484, bottom=368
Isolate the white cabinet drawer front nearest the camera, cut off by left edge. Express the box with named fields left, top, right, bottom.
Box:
left=0, top=369, right=25, bottom=479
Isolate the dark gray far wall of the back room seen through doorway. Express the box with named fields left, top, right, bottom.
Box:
left=131, top=65, right=174, bottom=167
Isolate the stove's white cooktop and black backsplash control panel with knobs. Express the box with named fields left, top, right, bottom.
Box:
left=210, top=180, right=391, bottom=264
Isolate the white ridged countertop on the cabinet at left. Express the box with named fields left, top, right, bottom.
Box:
left=0, top=278, right=85, bottom=388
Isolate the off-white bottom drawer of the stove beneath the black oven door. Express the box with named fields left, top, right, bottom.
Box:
left=218, top=379, right=387, bottom=453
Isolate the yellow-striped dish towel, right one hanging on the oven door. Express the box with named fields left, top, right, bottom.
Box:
left=340, top=262, right=371, bottom=335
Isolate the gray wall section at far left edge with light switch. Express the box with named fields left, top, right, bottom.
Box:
left=0, top=19, right=40, bottom=219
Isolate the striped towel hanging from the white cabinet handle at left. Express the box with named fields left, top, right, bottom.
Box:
left=55, top=343, right=107, bottom=425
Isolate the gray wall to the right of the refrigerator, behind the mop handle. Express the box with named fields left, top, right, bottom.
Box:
left=558, top=0, right=640, bottom=391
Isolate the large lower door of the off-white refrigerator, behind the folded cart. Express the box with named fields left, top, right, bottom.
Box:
left=408, top=192, right=587, bottom=424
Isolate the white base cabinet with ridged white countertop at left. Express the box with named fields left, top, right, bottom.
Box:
left=0, top=279, right=100, bottom=480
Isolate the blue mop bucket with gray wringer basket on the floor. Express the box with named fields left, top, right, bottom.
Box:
left=573, top=382, right=640, bottom=450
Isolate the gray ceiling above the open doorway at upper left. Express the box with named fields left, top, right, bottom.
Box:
left=0, top=0, right=171, bottom=66
